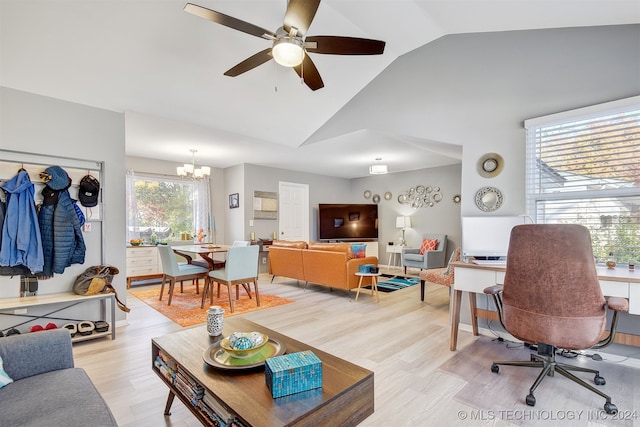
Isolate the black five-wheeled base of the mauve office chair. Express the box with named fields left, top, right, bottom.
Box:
left=491, top=349, right=618, bottom=415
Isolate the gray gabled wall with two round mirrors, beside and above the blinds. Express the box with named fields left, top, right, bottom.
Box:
left=307, top=25, right=640, bottom=216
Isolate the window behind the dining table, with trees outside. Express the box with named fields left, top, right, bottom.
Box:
left=127, top=172, right=215, bottom=241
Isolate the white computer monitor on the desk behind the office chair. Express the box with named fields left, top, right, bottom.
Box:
left=462, top=216, right=525, bottom=259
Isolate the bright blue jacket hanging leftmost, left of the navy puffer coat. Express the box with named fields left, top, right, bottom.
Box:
left=0, top=171, right=44, bottom=273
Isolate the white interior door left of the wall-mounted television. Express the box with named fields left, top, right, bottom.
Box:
left=278, top=182, right=309, bottom=242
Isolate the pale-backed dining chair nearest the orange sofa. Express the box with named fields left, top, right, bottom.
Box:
left=200, top=245, right=260, bottom=313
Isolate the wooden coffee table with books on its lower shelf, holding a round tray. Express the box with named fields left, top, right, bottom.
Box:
left=151, top=317, right=374, bottom=427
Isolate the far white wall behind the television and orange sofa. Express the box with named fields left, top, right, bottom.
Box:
left=239, top=165, right=461, bottom=259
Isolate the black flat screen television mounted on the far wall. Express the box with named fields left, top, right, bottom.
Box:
left=318, top=203, right=378, bottom=241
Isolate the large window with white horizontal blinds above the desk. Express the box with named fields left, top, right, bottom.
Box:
left=525, top=97, right=640, bottom=263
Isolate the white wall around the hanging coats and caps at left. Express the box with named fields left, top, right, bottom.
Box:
left=0, top=87, right=126, bottom=320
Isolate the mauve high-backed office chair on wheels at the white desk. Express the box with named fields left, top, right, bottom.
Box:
left=484, top=224, right=629, bottom=414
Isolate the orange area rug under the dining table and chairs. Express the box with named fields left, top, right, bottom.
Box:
left=129, top=283, right=293, bottom=326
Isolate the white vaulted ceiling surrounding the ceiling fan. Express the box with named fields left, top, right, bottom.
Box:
left=0, top=0, right=640, bottom=178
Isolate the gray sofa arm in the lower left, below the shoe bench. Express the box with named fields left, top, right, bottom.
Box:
left=0, top=329, right=74, bottom=381
